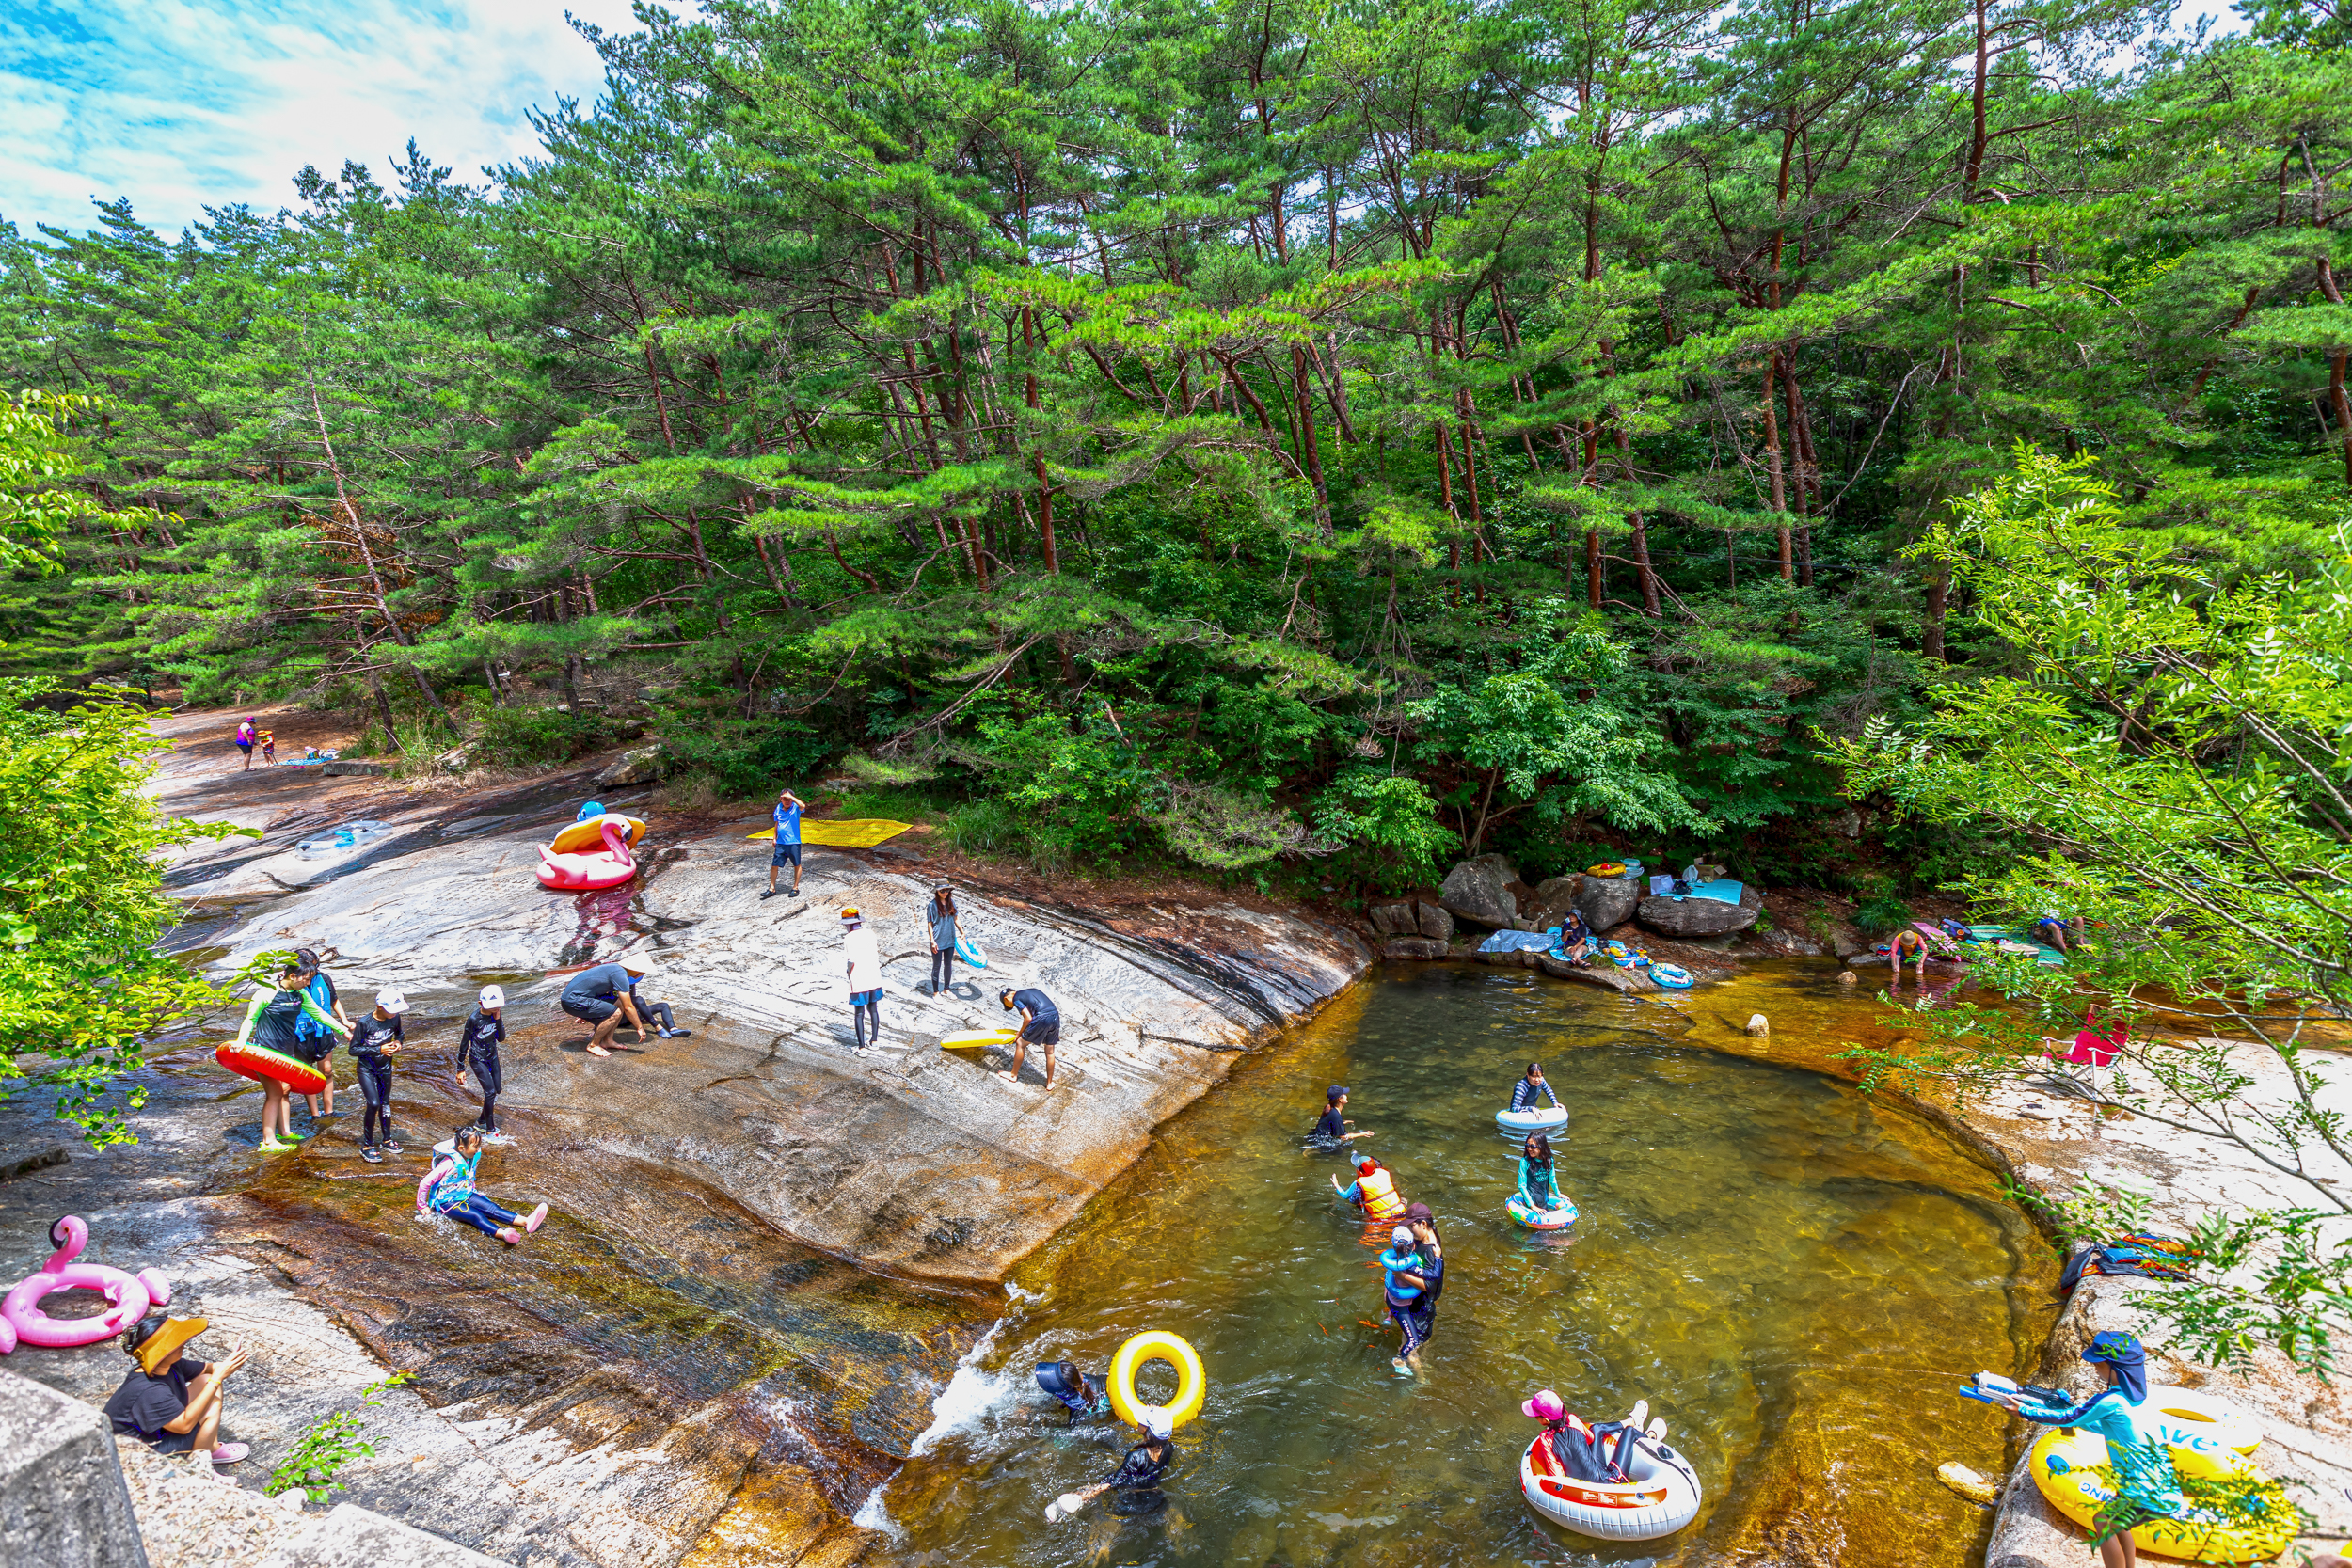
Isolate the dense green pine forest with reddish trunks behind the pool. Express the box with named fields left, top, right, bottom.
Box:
left=0, top=0, right=2352, bottom=877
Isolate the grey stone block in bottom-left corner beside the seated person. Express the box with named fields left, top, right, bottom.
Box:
left=0, top=1356, right=146, bottom=1568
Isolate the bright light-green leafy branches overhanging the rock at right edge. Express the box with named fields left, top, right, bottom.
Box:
left=1839, top=451, right=2352, bottom=1373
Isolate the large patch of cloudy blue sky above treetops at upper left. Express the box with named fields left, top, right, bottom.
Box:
left=0, top=0, right=654, bottom=232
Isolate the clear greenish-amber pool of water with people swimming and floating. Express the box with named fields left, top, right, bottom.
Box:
left=868, top=969, right=2049, bottom=1568
